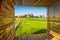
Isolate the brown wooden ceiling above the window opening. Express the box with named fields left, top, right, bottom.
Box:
left=14, top=0, right=59, bottom=6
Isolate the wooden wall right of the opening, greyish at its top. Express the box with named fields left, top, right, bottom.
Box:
left=48, top=2, right=60, bottom=40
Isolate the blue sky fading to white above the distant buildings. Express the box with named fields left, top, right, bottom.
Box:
left=14, top=5, right=47, bottom=17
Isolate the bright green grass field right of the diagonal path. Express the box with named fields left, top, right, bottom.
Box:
left=15, top=18, right=47, bottom=36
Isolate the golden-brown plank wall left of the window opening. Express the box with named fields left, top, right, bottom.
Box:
left=0, top=0, right=15, bottom=40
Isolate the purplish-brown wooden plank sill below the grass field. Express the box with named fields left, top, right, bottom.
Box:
left=14, top=33, right=48, bottom=40
